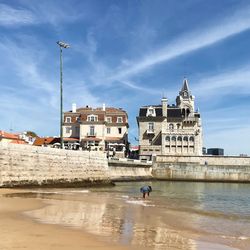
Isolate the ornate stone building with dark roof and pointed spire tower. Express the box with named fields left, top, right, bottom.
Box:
left=137, top=79, right=202, bottom=159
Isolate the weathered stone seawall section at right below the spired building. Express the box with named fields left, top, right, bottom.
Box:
left=152, top=156, right=250, bottom=183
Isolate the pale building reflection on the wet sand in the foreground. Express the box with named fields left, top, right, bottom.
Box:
left=27, top=193, right=196, bottom=250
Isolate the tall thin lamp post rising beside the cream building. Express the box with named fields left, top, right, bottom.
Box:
left=56, top=41, right=69, bottom=148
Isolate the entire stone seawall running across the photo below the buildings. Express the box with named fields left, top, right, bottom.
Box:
left=0, top=143, right=250, bottom=187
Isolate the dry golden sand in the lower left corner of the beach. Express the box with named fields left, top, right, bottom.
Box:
left=0, top=189, right=131, bottom=250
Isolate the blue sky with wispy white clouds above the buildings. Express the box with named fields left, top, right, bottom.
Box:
left=0, top=0, right=250, bottom=155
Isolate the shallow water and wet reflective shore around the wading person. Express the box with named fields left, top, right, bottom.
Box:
left=10, top=182, right=250, bottom=250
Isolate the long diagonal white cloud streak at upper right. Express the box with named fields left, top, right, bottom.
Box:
left=110, top=8, right=250, bottom=80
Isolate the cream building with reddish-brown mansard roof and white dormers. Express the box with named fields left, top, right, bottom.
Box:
left=63, top=104, right=128, bottom=157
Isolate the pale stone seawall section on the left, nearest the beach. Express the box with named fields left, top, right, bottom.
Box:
left=0, top=143, right=111, bottom=187
